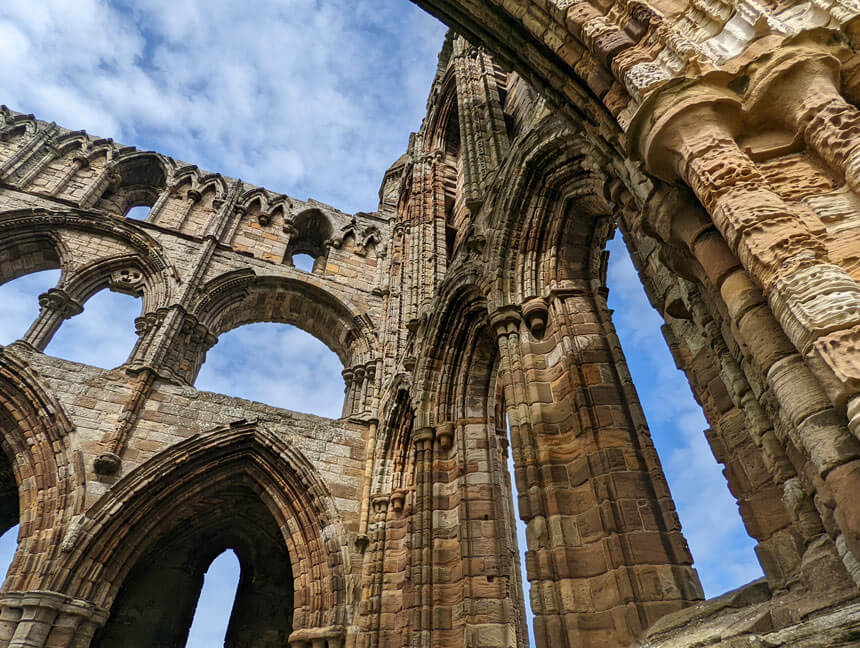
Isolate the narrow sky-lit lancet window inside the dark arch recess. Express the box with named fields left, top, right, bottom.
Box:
left=185, top=549, right=240, bottom=648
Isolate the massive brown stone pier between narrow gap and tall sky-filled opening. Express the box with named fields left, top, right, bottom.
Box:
left=491, top=296, right=703, bottom=648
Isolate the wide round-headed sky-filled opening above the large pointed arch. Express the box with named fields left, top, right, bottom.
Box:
left=195, top=322, right=344, bottom=418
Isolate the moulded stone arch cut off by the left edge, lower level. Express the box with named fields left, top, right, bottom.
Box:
left=0, top=350, right=86, bottom=592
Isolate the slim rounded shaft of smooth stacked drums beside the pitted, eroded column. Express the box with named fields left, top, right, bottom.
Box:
left=649, top=181, right=860, bottom=579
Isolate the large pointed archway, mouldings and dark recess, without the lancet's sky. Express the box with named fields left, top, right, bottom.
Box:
left=51, top=424, right=350, bottom=647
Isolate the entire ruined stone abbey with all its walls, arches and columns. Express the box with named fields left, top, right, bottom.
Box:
left=0, top=0, right=860, bottom=648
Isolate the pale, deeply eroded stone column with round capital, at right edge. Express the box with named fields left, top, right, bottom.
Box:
left=641, top=91, right=860, bottom=410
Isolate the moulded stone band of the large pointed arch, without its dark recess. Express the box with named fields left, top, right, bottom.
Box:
left=51, top=423, right=351, bottom=636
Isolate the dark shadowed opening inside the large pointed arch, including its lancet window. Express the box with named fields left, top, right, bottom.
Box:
left=91, top=486, right=295, bottom=648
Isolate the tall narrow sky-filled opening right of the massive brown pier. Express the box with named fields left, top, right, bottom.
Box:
left=607, top=235, right=762, bottom=597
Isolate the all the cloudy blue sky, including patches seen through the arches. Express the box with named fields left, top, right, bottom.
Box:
left=0, top=0, right=761, bottom=648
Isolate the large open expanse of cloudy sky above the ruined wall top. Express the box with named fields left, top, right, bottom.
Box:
left=0, top=0, right=444, bottom=211
